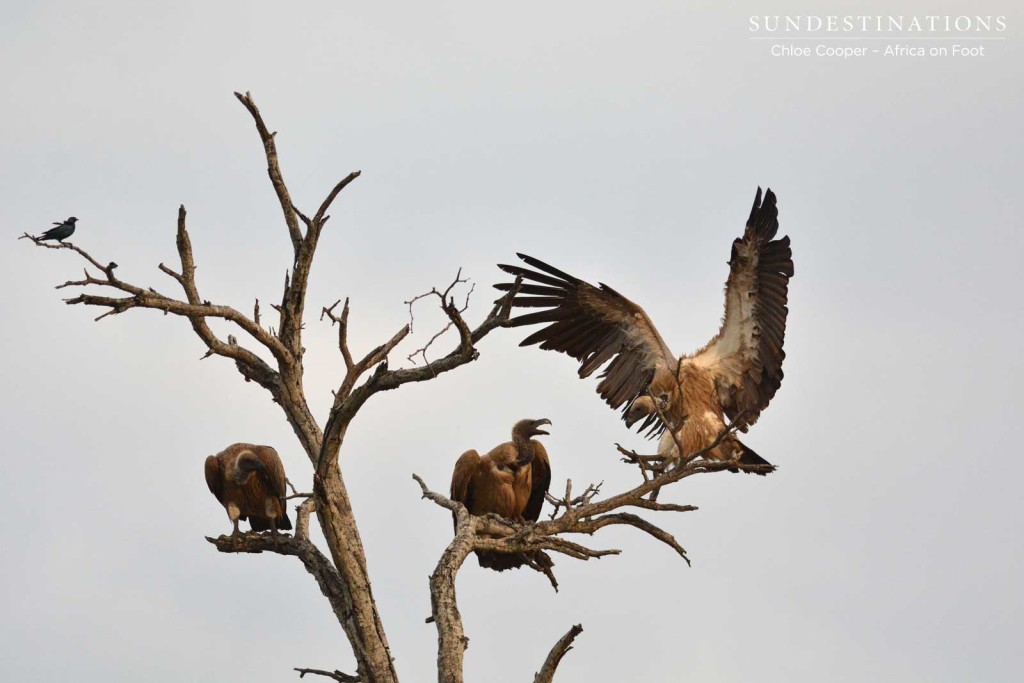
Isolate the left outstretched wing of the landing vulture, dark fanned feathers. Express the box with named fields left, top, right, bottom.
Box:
left=495, top=254, right=676, bottom=417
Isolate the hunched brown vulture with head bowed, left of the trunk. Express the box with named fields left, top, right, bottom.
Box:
left=206, top=443, right=292, bottom=536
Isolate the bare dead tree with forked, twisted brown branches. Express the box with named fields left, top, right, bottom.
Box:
left=23, top=93, right=770, bottom=683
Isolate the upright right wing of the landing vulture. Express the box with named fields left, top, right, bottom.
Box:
left=692, top=187, right=793, bottom=431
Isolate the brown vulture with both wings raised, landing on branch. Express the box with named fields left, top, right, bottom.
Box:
left=495, top=187, right=793, bottom=474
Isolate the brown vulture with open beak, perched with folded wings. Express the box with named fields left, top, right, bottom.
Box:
left=452, top=419, right=551, bottom=571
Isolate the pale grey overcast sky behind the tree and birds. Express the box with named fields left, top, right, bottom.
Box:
left=0, top=0, right=1024, bottom=683
